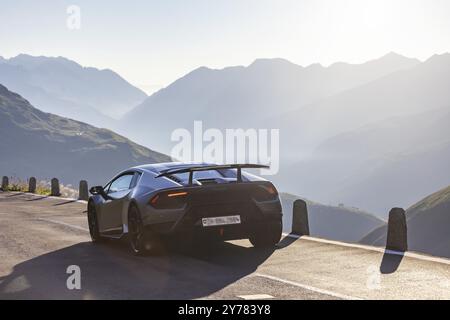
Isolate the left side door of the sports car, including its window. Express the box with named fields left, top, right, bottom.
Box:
left=99, top=172, right=135, bottom=234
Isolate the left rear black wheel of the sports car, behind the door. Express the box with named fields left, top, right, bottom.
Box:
left=128, top=205, right=161, bottom=256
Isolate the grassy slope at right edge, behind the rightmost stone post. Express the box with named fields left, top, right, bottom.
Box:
left=361, top=187, right=450, bottom=258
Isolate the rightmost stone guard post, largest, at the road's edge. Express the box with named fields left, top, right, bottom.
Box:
left=386, top=208, right=408, bottom=252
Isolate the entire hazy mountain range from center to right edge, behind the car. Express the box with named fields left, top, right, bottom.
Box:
left=116, top=53, right=450, bottom=218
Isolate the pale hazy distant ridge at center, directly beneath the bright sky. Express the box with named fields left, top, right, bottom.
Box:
left=119, top=53, right=419, bottom=152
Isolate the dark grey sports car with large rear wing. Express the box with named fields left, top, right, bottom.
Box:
left=88, top=163, right=282, bottom=254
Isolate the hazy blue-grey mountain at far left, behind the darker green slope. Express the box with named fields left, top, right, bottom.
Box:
left=0, top=54, right=147, bottom=127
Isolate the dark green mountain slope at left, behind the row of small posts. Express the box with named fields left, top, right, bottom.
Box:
left=0, top=85, right=169, bottom=185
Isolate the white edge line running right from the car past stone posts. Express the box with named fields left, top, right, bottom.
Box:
left=283, top=233, right=450, bottom=265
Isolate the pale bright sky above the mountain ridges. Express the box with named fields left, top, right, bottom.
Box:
left=0, top=0, right=450, bottom=93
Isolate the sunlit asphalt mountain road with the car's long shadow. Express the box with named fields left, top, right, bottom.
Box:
left=0, top=192, right=450, bottom=299
